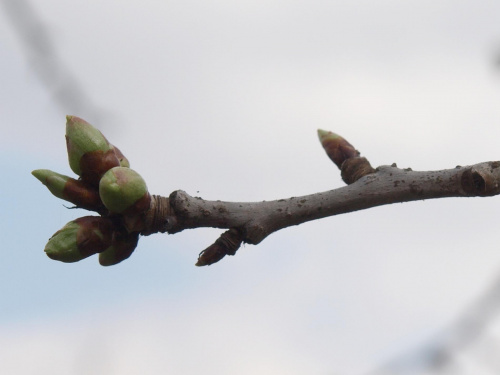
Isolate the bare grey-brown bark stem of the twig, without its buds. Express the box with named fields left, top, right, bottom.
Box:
left=143, top=162, right=500, bottom=248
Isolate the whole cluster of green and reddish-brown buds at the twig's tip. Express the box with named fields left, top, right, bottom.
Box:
left=32, top=116, right=151, bottom=266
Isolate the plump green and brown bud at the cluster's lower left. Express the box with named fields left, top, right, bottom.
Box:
left=45, top=216, right=114, bottom=263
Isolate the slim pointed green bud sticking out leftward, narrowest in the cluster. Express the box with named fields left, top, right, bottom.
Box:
left=31, top=169, right=103, bottom=211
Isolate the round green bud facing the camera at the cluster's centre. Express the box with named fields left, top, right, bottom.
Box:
left=99, top=167, right=151, bottom=215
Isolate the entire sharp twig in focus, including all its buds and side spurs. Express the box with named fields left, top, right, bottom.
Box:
left=32, top=120, right=500, bottom=266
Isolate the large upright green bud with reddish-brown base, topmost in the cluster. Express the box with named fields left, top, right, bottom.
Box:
left=66, top=116, right=120, bottom=185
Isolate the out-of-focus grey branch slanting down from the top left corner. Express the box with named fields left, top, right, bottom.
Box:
left=0, top=0, right=108, bottom=123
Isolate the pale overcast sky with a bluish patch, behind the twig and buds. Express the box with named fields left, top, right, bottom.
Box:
left=0, top=0, right=500, bottom=375
